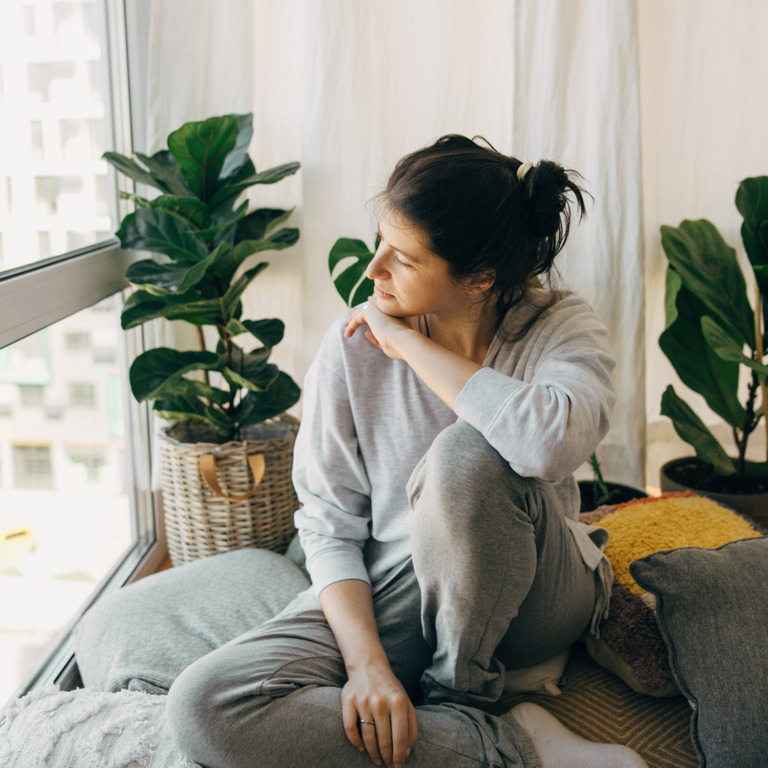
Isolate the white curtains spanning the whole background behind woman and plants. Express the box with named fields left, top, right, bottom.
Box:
left=138, top=0, right=768, bottom=484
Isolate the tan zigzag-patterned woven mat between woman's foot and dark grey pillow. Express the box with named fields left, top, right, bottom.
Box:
left=494, top=643, right=698, bottom=768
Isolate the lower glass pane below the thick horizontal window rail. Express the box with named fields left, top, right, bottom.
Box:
left=0, top=299, right=135, bottom=704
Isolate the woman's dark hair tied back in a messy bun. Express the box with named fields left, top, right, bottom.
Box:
left=381, top=134, right=585, bottom=319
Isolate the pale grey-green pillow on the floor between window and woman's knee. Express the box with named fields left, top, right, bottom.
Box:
left=75, top=549, right=309, bottom=694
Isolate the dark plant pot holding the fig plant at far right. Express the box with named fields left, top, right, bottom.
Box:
left=661, top=456, right=768, bottom=528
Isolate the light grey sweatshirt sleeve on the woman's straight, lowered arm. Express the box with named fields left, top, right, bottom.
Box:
left=293, top=324, right=371, bottom=593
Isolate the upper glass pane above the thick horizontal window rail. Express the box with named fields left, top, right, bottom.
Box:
left=0, top=0, right=116, bottom=272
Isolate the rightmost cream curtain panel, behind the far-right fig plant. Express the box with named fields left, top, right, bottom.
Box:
left=638, top=0, right=768, bottom=484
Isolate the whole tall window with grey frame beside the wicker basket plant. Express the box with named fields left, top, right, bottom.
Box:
left=0, top=0, right=163, bottom=708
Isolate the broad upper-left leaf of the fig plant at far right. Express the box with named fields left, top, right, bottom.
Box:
left=661, top=219, right=755, bottom=349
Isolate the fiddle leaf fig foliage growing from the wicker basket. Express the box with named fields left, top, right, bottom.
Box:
left=104, top=114, right=300, bottom=442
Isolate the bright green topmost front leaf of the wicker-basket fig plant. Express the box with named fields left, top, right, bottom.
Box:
left=168, top=115, right=239, bottom=202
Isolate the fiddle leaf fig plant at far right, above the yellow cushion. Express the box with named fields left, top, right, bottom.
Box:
left=659, top=176, right=768, bottom=477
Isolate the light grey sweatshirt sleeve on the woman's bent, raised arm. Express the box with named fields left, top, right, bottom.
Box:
left=455, top=304, right=615, bottom=482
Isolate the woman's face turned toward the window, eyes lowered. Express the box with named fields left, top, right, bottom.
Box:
left=366, top=208, right=486, bottom=318
